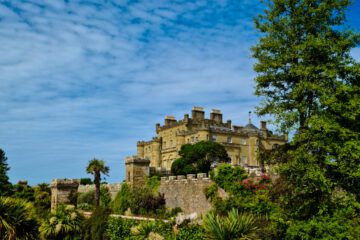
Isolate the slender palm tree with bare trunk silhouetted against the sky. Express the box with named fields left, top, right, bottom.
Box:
left=86, top=158, right=110, bottom=208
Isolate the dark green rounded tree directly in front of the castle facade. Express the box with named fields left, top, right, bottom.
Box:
left=171, top=141, right=230, bottom=175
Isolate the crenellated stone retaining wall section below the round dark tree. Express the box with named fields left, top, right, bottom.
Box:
left=159, top=173, right=212, bottom=214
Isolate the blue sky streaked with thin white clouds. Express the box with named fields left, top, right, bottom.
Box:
left=0, top=0, right=360, bottom=184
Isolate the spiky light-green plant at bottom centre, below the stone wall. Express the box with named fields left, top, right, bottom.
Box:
left=203, top=209, right=257, bottom=240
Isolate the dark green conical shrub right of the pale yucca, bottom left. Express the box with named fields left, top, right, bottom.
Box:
left=81, top=206, right=110, bottom=240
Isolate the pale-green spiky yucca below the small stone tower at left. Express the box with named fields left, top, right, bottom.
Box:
left=39, top=205, right=83, bottom=240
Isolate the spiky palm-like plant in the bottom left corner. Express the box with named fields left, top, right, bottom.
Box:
left=0, top=197, right=38, bottom=240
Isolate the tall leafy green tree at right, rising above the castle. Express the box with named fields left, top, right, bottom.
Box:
left=252, top=0, right=360, bottom=219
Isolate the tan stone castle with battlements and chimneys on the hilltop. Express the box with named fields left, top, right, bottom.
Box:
left=132, top=107, right=287, bottom=171
